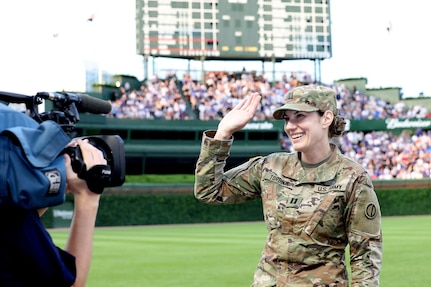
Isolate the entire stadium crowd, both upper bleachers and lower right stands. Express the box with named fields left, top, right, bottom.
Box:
left=108, top=72, right=431, bottom=180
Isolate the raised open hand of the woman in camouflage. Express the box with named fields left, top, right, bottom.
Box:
left=214, top=93, right=262, bottom=140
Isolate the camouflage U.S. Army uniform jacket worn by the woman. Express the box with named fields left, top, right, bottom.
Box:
left=194, top=131, right=382, bottom=287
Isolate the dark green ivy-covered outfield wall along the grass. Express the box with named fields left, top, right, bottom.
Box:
left=42, top=180, right=431, bottom=228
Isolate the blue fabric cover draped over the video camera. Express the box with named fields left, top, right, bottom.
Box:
left=0, top=104, right=70, bottom=209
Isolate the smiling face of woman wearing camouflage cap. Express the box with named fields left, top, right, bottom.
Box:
left=283, top=110, right=334, bottom=163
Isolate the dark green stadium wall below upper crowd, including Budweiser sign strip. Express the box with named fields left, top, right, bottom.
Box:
left=76, top=114, right=431, bottom=174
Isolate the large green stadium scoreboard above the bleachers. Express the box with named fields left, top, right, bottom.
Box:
left=136, top=0, right=332, bottom=61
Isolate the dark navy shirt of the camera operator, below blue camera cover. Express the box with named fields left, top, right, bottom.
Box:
left=0, top=207, right=76, bottom=287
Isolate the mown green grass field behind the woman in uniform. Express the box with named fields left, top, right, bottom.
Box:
left=50, top=216, right=431, bottom=287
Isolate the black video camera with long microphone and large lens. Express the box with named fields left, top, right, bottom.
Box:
left=0, top=91, right=125, bottom=197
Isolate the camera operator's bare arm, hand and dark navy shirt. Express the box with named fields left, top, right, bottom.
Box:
left=0, top=139, right=106, bottom=287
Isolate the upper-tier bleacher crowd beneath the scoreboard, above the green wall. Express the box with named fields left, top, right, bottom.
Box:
left=109, top=72, right=428, bottom=120
